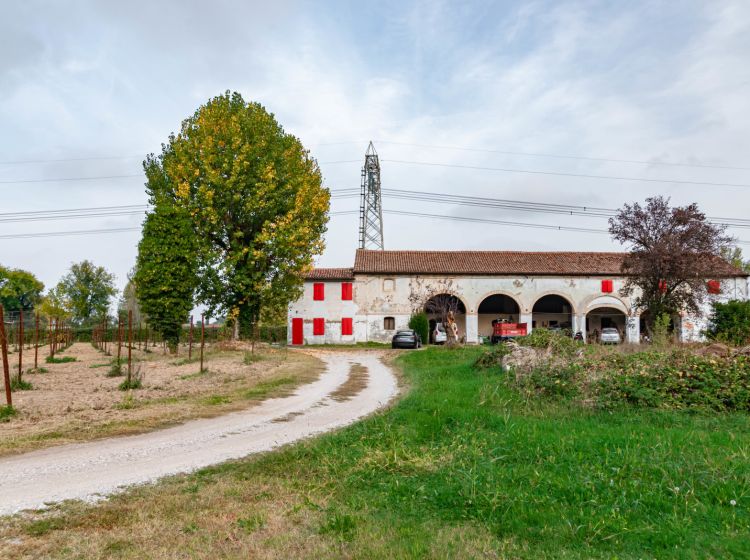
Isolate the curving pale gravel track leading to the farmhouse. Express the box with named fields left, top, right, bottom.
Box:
left=0, top=351, right=397, bottom=515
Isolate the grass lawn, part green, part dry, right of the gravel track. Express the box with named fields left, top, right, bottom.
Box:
left=0, top=348, right=750, bottom=559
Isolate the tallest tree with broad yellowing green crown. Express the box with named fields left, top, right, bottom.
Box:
left=147, top=92, right=330, bottom=336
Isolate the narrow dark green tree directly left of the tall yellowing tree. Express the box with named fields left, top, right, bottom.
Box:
left=133, top=195, right=197, bottom=352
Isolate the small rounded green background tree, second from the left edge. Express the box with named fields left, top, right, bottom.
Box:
left=55, top=261, right=117, bottom=325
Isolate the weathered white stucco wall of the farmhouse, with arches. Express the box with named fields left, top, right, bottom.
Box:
left=289, top=275, right=749, bottom=344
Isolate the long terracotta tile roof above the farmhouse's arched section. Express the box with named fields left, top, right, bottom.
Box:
left=353, top=249, right=747, bottom=276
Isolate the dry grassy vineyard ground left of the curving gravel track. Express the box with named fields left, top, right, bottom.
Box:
left=0, top=343, right=324, bottom=456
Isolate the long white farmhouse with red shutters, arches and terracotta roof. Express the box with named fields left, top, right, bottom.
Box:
left=289, top=249, right=750, bottom=345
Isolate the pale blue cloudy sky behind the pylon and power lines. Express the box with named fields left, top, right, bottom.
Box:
left=0, top=0, right=750, bottom=296
